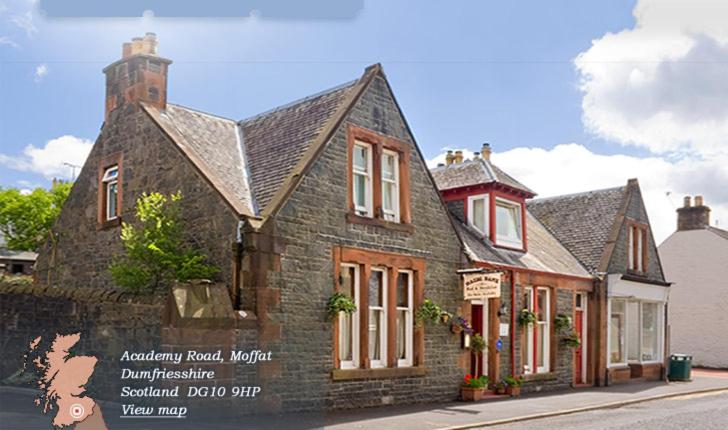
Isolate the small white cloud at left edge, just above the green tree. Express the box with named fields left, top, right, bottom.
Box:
left=0, top=135, right=93, bottom=179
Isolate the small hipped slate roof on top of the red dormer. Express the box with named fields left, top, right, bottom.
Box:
left=431, top=158, right=536, bottom=196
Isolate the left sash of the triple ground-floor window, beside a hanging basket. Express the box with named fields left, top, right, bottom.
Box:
left=339, top=264, right=361, bottom=369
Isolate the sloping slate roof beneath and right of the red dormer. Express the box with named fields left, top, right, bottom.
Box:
left=456, top=211, right=590, bottom=278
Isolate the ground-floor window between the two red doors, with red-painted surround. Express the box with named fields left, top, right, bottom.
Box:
left=523, top=286, right=554, bottom=375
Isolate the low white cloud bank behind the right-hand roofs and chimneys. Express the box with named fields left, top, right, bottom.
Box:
left=428, top=143, right=728, bottom=243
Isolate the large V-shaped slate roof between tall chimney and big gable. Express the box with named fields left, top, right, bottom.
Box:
left=143, top=74, right=366, bottom=216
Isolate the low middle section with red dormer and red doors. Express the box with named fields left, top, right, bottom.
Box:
left=432, top=148, right=594, bottom=391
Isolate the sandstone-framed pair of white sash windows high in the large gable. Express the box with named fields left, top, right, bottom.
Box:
left=347, top=125, right=413, bottom=231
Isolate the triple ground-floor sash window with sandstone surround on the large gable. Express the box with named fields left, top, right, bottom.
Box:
left=332, top=247, right=425, bottom=380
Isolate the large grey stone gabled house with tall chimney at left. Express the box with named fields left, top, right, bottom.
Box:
left=37, top=34, right=467, bottom=411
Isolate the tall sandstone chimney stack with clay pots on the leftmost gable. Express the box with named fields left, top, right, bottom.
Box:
left=104, top=33, right=172, bottom=120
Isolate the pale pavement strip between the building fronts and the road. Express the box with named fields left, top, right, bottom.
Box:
left=326, top=369, right=728, bottom=430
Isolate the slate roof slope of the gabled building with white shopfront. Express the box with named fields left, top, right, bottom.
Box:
left=527, top=186, right=627, bottom=273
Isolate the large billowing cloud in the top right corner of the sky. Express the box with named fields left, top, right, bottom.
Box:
left=575, top=0, right=728, bottom=157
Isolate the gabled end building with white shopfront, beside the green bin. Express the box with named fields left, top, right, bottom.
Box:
left=527, top=179, right=670, bottom=385
